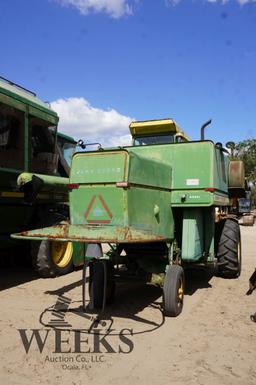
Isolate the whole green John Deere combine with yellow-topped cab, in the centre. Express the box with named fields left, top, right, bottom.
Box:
left=13, top=119, right=244, bottom=316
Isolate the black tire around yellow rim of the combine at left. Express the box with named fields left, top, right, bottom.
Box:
left=31, top=213, right=74, bottom=278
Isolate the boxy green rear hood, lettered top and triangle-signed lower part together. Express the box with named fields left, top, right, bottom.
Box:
left=70, top=150, right=174, bottom=239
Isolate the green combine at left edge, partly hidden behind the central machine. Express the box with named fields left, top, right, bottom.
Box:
left=0, top=78, right=84, bottom=277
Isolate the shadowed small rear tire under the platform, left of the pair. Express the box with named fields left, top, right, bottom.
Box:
left=89, top=260, right=116, bottom=309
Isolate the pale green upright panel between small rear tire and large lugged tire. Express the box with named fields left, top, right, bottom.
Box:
left=181, top=208, right=204, bottom=261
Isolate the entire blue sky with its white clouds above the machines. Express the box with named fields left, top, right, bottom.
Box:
left=0, top=0, right=256, bottom=144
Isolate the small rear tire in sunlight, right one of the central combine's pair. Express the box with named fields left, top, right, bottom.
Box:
left=163, top=265, right=185, bottom=317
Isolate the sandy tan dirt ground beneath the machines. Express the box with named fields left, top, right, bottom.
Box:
left=0, top=226, right=256, bottom=385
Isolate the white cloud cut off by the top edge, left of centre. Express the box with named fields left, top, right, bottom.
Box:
left=55, top=0, right=134, bottom=19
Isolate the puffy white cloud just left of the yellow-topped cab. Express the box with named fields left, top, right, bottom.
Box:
left=51, top=98, right=134, bottom=147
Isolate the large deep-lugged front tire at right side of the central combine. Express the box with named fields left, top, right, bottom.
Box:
left=217, top=219, right=242, bottom=278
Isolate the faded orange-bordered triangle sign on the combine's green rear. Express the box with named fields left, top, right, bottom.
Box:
left=84, top=195, right=113, bottom=224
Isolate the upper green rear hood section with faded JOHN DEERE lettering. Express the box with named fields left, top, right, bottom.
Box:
left=70, top=150, right=172, bottom=189
